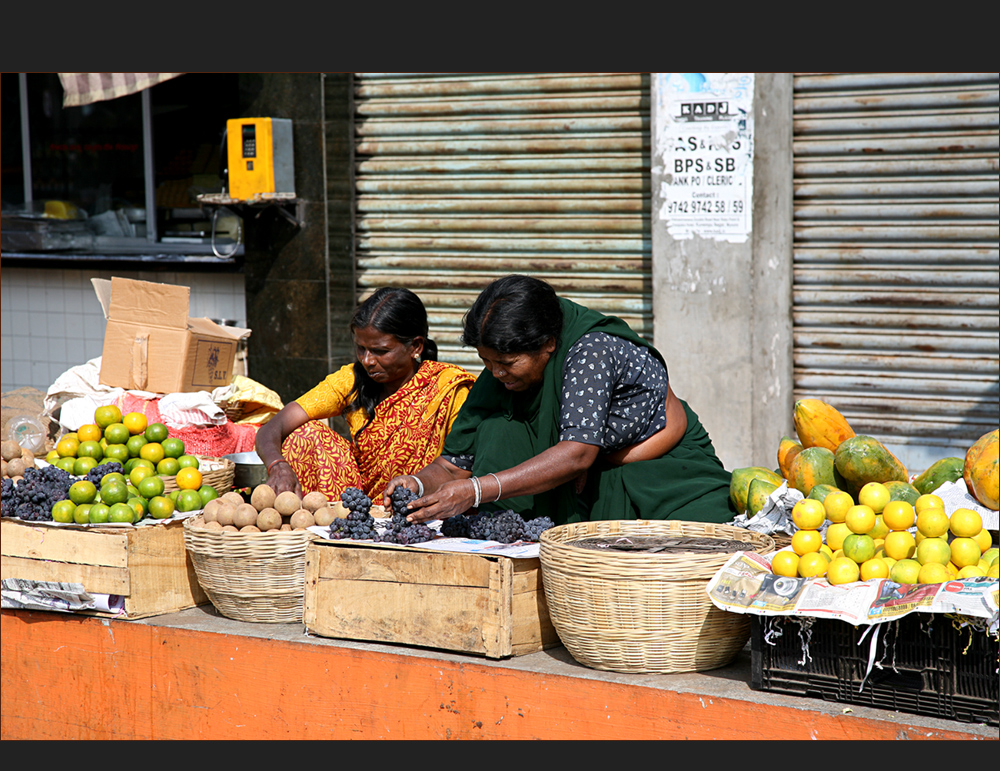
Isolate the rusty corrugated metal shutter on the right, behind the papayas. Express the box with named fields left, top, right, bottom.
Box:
left=793, top=72, right=1000, bottom=469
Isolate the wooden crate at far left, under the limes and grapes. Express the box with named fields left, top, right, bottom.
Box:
left=0, top=520, right=208, bottom=618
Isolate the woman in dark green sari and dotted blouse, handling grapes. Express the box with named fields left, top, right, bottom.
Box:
left=385, top=275, right=735, bottom=524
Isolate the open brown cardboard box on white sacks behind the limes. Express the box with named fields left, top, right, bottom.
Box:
left=91, top=277, right=250, bottom=394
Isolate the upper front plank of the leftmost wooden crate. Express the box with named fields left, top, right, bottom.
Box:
left=0, top=520, right=133, bottom=568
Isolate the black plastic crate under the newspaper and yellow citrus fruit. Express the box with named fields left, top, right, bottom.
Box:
left=750, top=613, right=1000, bottom=726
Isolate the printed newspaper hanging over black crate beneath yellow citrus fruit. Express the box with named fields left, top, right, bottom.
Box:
left=707, top=552, right=1000, bottom=634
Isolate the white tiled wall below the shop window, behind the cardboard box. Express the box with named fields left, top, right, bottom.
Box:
left=0, top=267, right=247, bottom=393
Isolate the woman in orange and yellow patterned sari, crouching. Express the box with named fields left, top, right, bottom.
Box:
left=256, top=287, right=475, bottom=500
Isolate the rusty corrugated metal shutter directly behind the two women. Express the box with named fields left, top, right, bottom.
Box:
left=354, top=73, right=652, bottom=371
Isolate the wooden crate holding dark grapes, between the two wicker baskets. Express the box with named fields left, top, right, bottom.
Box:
left=302, top=541, right=559, bottom=659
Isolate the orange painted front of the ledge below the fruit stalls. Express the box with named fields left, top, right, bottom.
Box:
left=0, top=610, right=997, bottom=740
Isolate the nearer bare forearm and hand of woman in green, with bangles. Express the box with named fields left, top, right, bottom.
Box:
left=402, top=442, right=601, bottom=522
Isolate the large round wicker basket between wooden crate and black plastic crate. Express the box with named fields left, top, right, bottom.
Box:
left=540, top=520, right=774, bottom=673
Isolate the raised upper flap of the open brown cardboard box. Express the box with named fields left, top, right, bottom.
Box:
left=91, top=277, right=191, bottom=329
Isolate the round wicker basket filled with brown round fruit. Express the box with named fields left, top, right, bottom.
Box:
left=184, top=514, right=316, bottom=624
